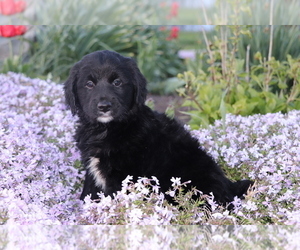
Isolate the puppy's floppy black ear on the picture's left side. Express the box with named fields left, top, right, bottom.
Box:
left=64, top=64, right=79, bottom=115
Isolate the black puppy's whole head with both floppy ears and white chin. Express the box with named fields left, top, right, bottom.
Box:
left=64, top=50, right=147, bottom=123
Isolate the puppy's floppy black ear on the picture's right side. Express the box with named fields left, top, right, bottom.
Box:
left=130, top=59, right=147, bottom=106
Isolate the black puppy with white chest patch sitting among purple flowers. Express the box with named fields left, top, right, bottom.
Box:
left=64, top=51, right=253, bottom=204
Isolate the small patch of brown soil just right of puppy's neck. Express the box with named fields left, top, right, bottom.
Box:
left=147, top=94, right=190, bottom=123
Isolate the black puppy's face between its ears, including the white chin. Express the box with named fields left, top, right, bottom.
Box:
left=77, top=60, right=134, bottom=123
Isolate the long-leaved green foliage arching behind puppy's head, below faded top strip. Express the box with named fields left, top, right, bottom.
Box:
left=18, top=25, right=183, bottom=82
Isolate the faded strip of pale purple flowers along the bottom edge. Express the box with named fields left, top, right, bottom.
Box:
left=0, top=224, right=300, bottom=250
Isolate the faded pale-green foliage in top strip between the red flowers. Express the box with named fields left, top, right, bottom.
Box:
left=34, top=0, right=165, bottom=25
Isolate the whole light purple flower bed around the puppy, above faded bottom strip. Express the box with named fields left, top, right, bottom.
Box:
left=0, top=73, right=300, bottom=225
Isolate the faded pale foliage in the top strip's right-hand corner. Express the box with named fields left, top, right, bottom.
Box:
left=195, top=0, right=299, bottom=25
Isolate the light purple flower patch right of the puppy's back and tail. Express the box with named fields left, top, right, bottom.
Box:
left=191, top=111, right=300, bottom=224
